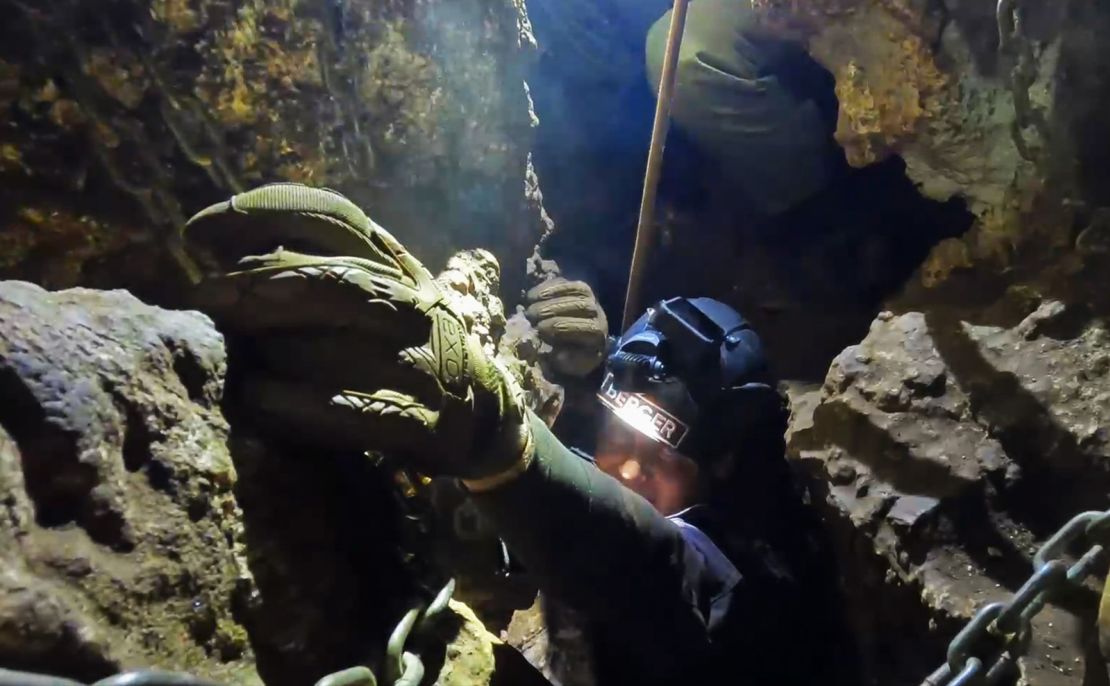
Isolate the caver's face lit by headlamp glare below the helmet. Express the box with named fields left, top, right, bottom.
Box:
left=595, top=413, right=698, bottom=515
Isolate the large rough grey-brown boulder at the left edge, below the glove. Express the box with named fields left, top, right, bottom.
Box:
left=0, top=282, right=261, bottom=684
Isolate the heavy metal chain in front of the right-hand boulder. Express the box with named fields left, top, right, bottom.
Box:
left=922, top=511, right=1110, bottom=686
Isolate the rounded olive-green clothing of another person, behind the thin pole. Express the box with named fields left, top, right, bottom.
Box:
left=646, top=0, right=835, bottom=215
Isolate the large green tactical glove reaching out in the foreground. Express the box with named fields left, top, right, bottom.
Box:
left=184, top=183, right=532, bottom=488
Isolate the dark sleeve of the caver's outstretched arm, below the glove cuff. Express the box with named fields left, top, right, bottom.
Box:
left=474, top=415, right=712, bottom=663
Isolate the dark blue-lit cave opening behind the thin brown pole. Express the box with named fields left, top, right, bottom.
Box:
left=529, top=0, right=972, bottom=381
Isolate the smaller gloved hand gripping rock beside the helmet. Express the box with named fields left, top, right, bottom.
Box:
left=525, top=278, right=609, bottom=376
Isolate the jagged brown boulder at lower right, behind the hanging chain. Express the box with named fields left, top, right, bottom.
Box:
left=788, top=301, right=1110, bottom=685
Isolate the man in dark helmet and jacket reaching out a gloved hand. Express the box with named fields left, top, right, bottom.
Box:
left=185, top=184, right=851, bottom=686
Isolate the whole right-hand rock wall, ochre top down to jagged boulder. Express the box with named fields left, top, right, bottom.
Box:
left=763, top=0, right=1110, bottom=684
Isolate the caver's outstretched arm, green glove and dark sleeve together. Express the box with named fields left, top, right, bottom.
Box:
left=185, top=184, right=728, bottom=684
